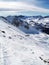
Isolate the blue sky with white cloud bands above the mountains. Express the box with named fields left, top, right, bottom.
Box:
left=0, top=0, right=49, bottom=16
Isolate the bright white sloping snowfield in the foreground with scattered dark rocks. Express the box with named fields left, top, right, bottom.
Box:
left=0, top=20, right=49, bottom=65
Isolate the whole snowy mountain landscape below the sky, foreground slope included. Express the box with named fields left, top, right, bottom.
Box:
left=0, top=16, right=49, bottom=65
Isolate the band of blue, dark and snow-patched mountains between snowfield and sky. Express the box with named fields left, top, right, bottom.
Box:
left=0, top=15, right=49, bottom=34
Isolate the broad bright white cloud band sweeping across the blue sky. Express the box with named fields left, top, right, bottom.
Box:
left=0, top=2, right=49, bottom=13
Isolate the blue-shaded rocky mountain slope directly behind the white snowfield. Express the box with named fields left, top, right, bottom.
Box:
left=0, top=16, right=39, bottom=34
